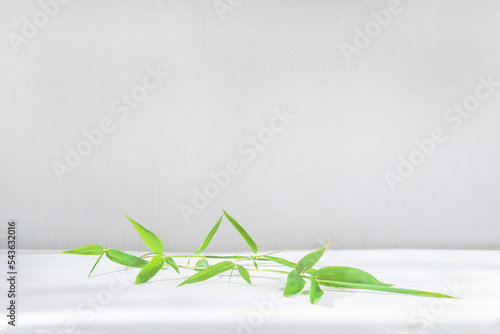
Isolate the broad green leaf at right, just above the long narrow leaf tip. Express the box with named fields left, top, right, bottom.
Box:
left=314, top=266, right=393, bottom=286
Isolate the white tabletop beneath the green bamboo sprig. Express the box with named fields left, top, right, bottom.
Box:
left=0, top=250, right=500, bottom=334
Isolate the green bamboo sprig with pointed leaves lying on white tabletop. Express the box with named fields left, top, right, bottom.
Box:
left=62, top=210, right=454, bottom=304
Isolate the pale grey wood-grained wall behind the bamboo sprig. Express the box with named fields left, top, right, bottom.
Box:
left=0, top=0, right=500, bottom=251
